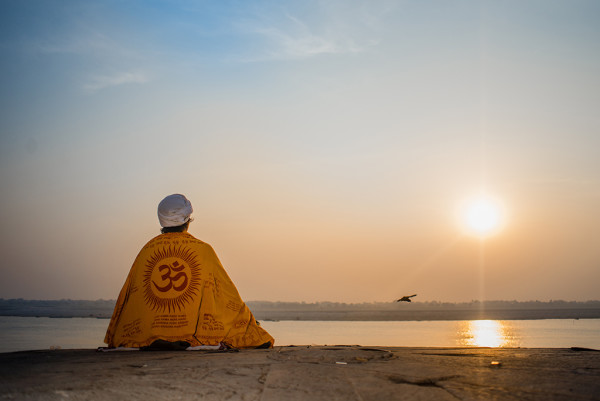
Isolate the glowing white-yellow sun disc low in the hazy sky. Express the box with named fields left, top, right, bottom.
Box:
left=460, top=195, right=504, bottom=237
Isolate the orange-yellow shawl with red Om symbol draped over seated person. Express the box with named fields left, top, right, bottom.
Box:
left=104, top=233, right=274, bottom=348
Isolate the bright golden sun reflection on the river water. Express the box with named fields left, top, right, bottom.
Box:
left=458, top=320, right=518, bottom=347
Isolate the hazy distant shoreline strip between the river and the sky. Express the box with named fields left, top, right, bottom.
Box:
left=0, top=299, right=600, bottom=321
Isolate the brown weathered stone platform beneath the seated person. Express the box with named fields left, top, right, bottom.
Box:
left=0, top=346, right=600, bottom=401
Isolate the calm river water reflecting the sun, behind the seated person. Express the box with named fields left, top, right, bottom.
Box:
left=0, top=316, right=600, bottom=352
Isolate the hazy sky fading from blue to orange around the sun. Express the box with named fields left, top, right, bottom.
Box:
left=0, top=0, right=600, bottom=303
